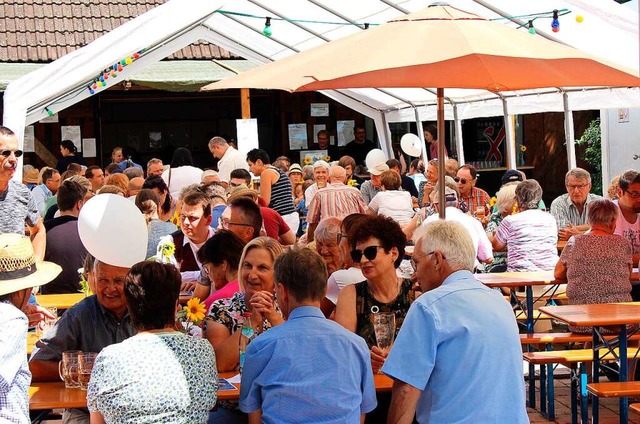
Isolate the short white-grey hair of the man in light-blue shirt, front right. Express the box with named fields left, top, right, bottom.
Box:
left=414, top=220, right=476, bottom=272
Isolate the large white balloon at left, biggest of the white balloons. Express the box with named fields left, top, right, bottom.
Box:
left=78, top=194, right=149, bottom=268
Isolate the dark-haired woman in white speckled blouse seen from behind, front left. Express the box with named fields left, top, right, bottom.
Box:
left=87, top=262, right=218, bottom=423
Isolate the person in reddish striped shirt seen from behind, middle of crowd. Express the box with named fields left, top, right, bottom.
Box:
left=307, top=165, right=367, bottom=242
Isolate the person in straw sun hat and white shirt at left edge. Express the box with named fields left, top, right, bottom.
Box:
left=0, top=234, right=61, bottom=423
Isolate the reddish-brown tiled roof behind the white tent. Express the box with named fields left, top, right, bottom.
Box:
left=0, top=0, right=237, bottom=62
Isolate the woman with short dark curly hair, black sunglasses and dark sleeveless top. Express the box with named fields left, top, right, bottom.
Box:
left=335, top=216, right=415, bottom=371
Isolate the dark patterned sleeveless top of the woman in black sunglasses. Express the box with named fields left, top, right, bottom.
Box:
left=354, top=279, right=416, bottom=349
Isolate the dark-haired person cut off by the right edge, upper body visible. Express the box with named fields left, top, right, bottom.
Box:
left=614, top=170, right=640, bottom=301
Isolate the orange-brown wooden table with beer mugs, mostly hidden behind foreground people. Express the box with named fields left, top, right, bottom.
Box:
left=29, top=372, right=393, bottom=411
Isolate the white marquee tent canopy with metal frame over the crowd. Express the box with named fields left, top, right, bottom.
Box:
left=3, top=0, right=640, bottom=172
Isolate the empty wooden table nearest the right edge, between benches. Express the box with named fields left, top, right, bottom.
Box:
left=540, top=302, right=640, bottom=424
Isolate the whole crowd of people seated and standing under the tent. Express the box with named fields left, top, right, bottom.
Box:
left=0, top=121, right=640, bottom=423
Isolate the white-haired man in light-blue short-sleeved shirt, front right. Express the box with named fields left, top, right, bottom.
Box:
left=382, top=221, right=529, bottom=424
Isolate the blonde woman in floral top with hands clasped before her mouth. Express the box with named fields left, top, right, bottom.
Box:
left=205, top=237, right=284, bottom=372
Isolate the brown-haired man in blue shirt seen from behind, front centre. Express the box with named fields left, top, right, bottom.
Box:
left=240, top=249, right=376, bottom=424
